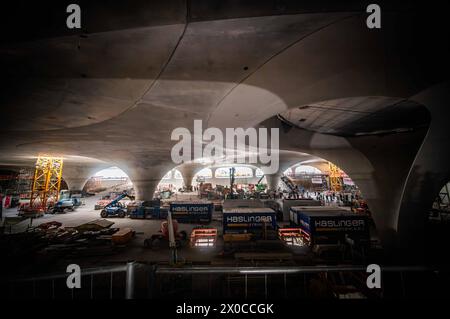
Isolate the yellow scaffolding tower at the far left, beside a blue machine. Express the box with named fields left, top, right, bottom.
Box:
left=29, top=156, right=63, bottom=211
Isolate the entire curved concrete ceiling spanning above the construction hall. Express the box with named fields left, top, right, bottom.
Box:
left=0, top=1, right=445, bottom=185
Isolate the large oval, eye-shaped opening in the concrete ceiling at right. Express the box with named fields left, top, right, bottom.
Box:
left=279, top=96, right=430, bottom=136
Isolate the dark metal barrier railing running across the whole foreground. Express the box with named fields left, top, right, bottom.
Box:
left=6, top=262, right=450, bottom=299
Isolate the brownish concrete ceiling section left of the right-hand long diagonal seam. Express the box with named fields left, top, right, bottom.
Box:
left=1, top=13, right=354, bottom=166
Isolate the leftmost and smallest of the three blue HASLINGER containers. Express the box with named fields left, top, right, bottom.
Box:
left=170, top=201, right=214, bottom=223
